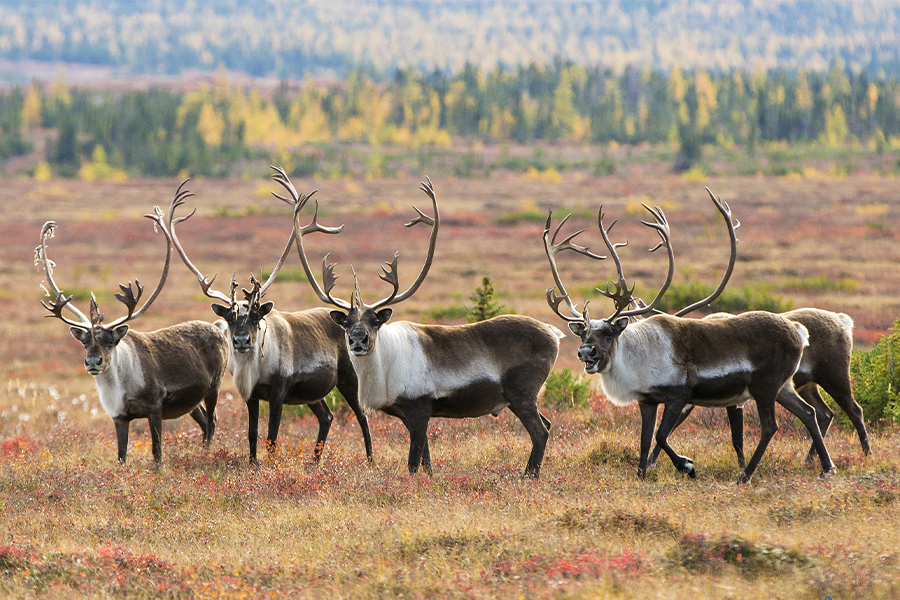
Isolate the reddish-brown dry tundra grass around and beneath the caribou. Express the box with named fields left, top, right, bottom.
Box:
left=0, top=173, right=900, bottom=598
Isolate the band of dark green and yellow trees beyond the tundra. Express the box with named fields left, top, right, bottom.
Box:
left=0, top=61, right=900, bottom=178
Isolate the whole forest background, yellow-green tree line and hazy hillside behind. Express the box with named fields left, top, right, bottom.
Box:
left=0, top=0, right=900, bottom=179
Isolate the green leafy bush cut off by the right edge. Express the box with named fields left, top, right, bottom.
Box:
left=850, top=319, right=900, bottom=426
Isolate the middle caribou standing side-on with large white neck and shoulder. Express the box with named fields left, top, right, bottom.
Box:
left=294, top=180, right=563, bottom=478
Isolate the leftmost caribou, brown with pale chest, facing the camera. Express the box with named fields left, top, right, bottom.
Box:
left=35, top=183, right=228, bottom=465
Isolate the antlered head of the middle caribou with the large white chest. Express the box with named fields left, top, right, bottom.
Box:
left=294, top=178, right=440, bottom=356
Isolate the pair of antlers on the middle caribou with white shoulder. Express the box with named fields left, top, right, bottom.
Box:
left=294, top=177, right=440, bottom=310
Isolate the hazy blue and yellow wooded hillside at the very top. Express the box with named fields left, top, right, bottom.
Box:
left=0, top=0, right=900, bottom=78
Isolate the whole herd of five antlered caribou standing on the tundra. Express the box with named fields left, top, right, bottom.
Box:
left=35, top=167, right=870, bottom=482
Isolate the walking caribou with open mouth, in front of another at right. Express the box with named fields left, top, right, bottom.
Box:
left=544, top=205, right=835, bottom=483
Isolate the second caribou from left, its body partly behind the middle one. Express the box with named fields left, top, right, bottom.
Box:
left=163, top=167, right=372, bottom=465
